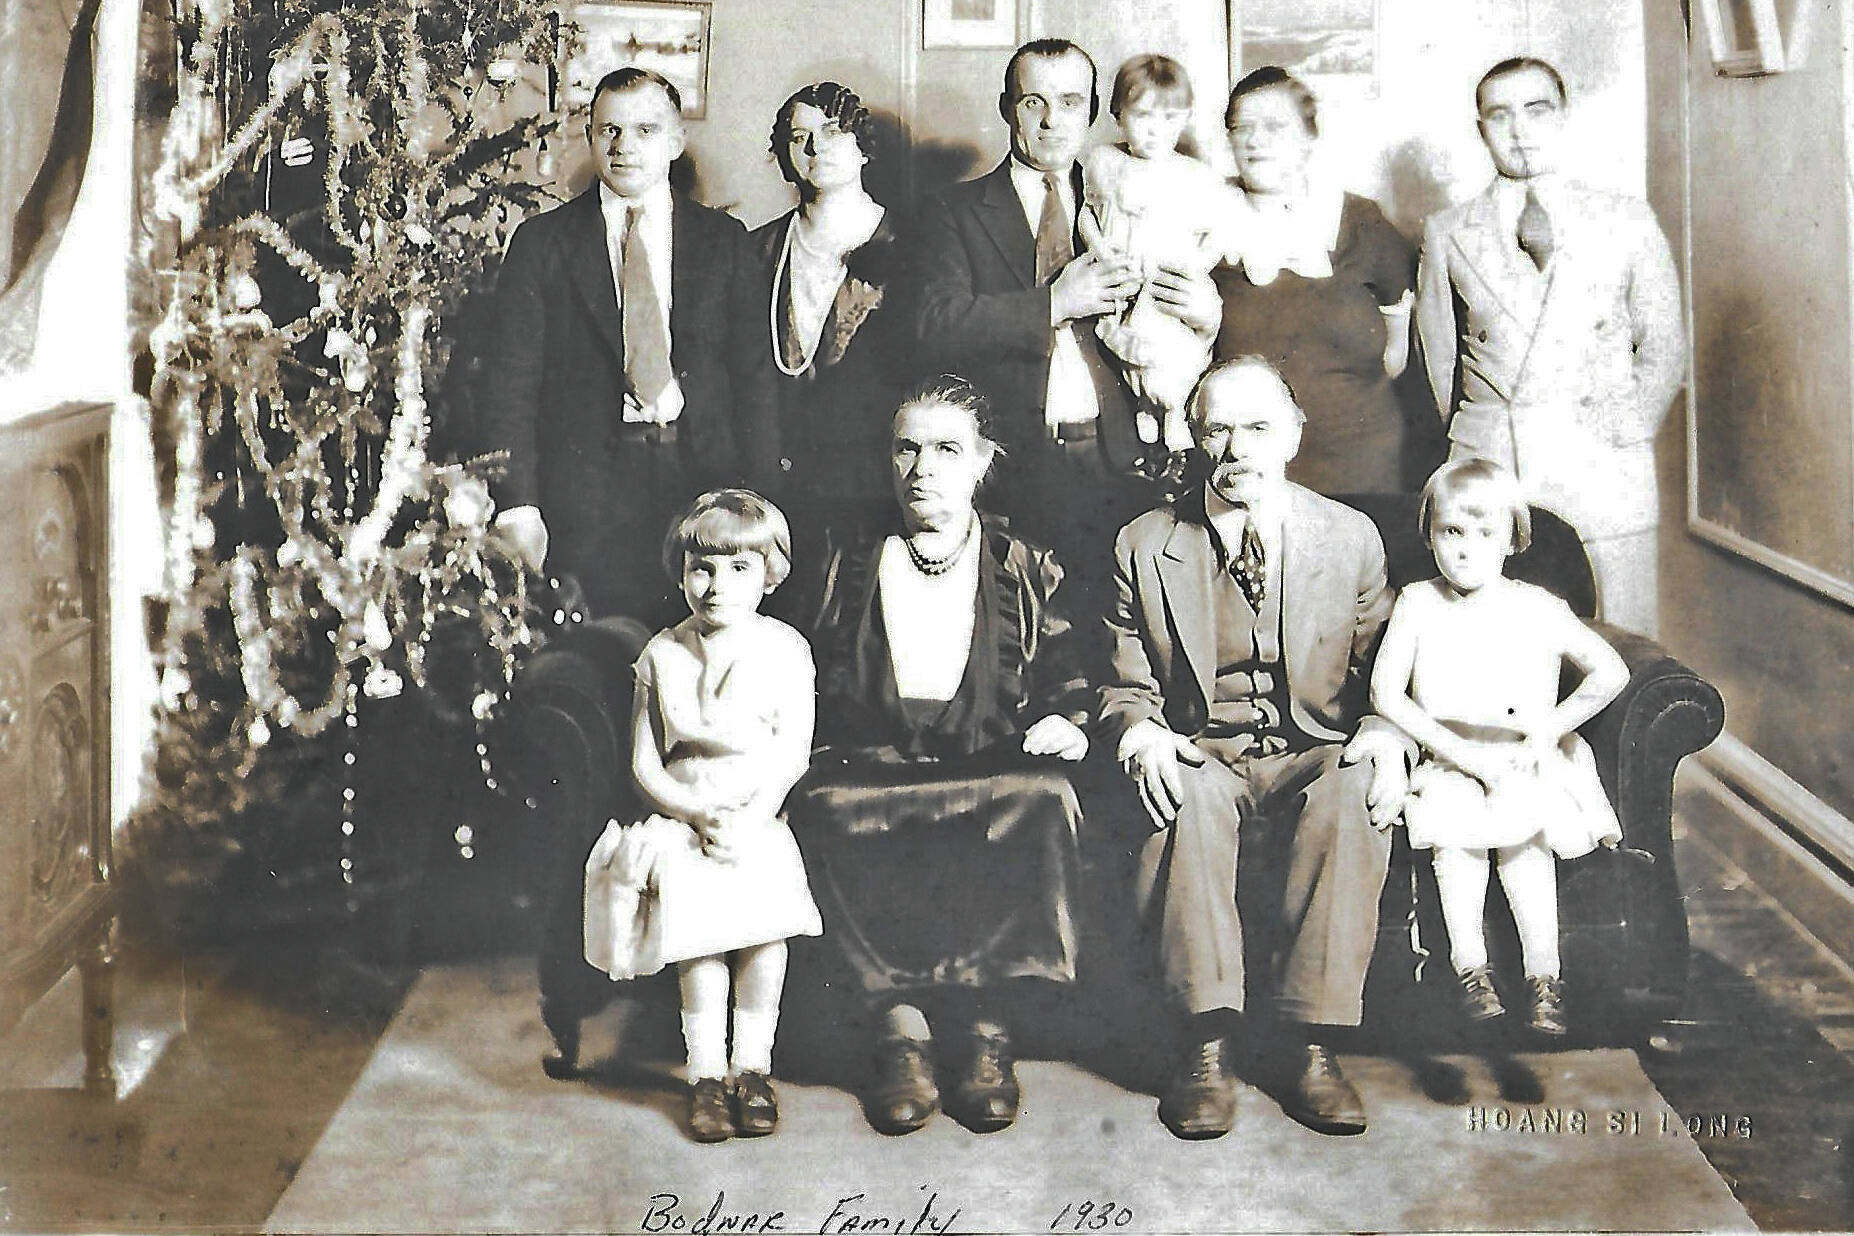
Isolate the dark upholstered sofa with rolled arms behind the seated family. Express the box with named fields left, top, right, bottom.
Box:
left=495, top=495, right=1724, bottom=1075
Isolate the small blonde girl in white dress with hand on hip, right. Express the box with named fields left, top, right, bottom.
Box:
left=1372, top=460, right=1628, bottom=1036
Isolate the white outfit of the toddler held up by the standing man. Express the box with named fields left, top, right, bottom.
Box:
left=1079, top=146, right=1235, bottom=448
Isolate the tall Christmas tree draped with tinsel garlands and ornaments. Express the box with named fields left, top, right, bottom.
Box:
left=132, top=0, right=560, bottom=919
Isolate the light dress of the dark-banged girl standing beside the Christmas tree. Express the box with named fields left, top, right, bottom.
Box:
left=586, top=615, right=823, bottom=978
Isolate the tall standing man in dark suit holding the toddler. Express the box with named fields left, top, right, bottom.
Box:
left=916, top=39, right=1142, bottom=608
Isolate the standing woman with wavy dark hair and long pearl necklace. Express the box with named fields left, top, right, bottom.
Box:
left=753, top=82, right=908, bottom=539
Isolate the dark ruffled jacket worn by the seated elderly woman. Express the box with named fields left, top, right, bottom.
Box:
left=812, top=515, right=1094, bottom=760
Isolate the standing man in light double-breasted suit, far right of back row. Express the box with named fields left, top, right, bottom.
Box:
left=1416, top=57, right=1685, bottom=636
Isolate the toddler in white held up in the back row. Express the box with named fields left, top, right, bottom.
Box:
left=1077, top=56, right=1235, bottom=463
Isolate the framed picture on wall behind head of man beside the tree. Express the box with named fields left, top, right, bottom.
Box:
left=562, top=0, right=714, bottom=120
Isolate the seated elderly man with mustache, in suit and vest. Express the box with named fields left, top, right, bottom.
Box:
left=1101, top=356, right=1407, bottom=1138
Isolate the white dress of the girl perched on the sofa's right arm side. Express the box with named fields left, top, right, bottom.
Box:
left=1387, top=580, right=1622, bottom=858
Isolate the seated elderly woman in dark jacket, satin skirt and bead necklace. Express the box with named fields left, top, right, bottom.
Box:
left=792, top=378, right=1092, bottom=1134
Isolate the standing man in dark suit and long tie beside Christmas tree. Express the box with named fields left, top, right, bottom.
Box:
left=484, top=67, right=777, bottom=624
